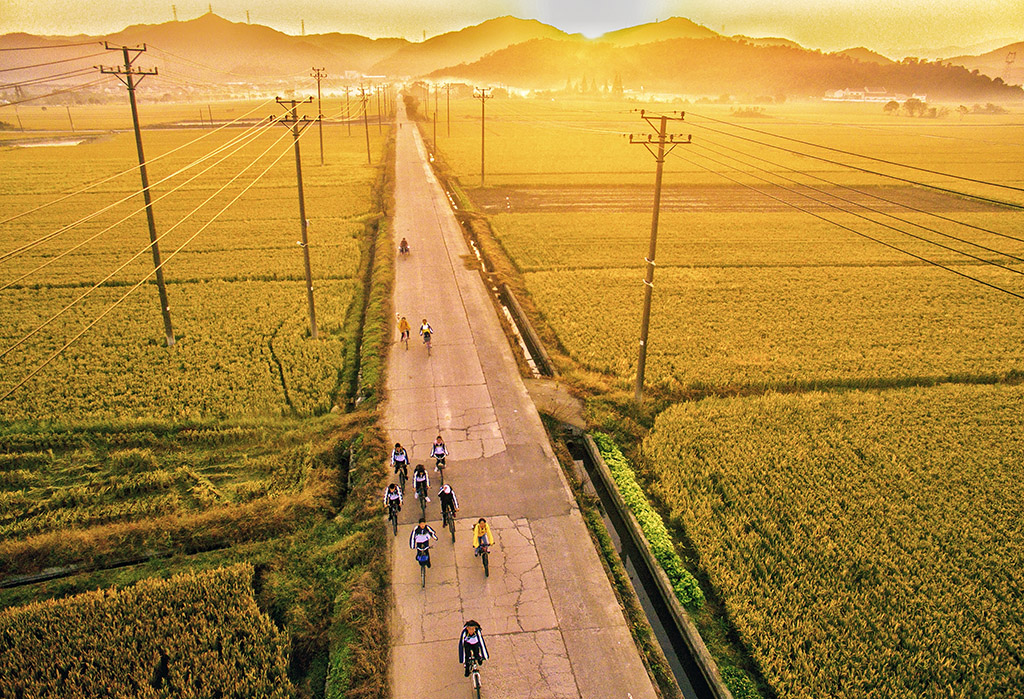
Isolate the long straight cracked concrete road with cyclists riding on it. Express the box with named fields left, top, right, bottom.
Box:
left=385, top=103, right=655, bottom=699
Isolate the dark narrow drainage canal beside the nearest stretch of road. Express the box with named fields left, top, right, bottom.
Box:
left=565, top=439, right=714, bottom=699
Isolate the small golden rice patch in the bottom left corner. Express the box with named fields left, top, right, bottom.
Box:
left=0, top=565, right=293, bottom=699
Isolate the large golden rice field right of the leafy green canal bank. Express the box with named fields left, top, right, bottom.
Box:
left=643, top=386, right=1024, bottom=699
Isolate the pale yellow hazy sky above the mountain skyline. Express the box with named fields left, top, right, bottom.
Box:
left=0, top=0, right=1024, bottom=53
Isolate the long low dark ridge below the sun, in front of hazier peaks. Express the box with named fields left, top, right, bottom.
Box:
left=433, top=37, right=1024, bottom=101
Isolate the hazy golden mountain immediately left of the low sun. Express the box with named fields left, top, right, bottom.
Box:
left=372, top=16, right=571, bottom=77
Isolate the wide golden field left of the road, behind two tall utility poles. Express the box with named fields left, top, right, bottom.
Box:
left=0, top=106, right=384, bottom=421
